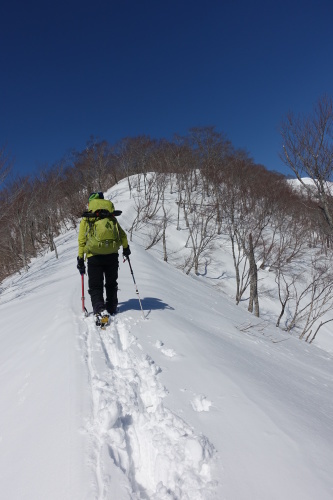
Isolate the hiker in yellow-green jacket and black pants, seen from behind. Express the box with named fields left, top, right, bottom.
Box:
left=77, top=192, right=131, bottom=324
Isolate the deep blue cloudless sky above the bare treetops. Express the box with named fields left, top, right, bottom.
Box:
left=0, top=0, right=333, bottom=177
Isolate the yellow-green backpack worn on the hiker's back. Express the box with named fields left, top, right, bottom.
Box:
left=83, top=200, right=121, bottom=255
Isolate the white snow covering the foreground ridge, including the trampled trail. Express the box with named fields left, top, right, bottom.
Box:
left=0, top=178, right=333, bottom=500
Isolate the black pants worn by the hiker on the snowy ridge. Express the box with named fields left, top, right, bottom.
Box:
left=88, top=253, right=119, bottom=314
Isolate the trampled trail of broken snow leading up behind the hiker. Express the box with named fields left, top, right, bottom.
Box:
left=84, top=315, right=217, bottom=500
